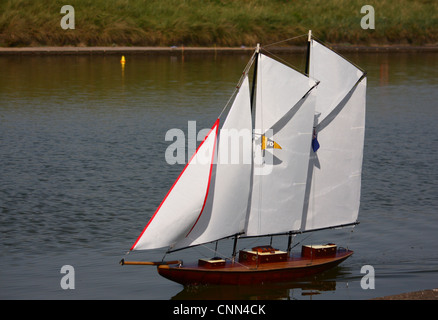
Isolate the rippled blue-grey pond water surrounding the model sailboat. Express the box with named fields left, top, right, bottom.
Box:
left=0, top=53, right=438, bottom=300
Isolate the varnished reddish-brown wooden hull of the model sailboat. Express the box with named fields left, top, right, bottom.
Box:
left=157, top=249, right=353, bottom=285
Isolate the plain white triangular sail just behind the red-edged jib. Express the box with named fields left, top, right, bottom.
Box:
left=173, top=76, right=252, bottom=250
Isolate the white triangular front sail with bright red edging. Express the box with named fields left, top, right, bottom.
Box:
left=131, top=119, right=219, bottom=250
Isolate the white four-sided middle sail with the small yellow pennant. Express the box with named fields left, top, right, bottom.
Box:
left=246, top=54, right=316, bottom=236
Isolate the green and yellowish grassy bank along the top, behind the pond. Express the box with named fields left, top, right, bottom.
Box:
left=0, top=0, right=438, bottom=47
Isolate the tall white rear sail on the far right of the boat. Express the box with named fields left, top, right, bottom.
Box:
left=301, top=40, right=366, bottom=231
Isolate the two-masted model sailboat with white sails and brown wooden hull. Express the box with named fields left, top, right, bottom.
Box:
left=121, top=32, right=366, bottom=285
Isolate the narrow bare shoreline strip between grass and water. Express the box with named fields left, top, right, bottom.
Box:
left=0, top=44, right=438, bottom=56
